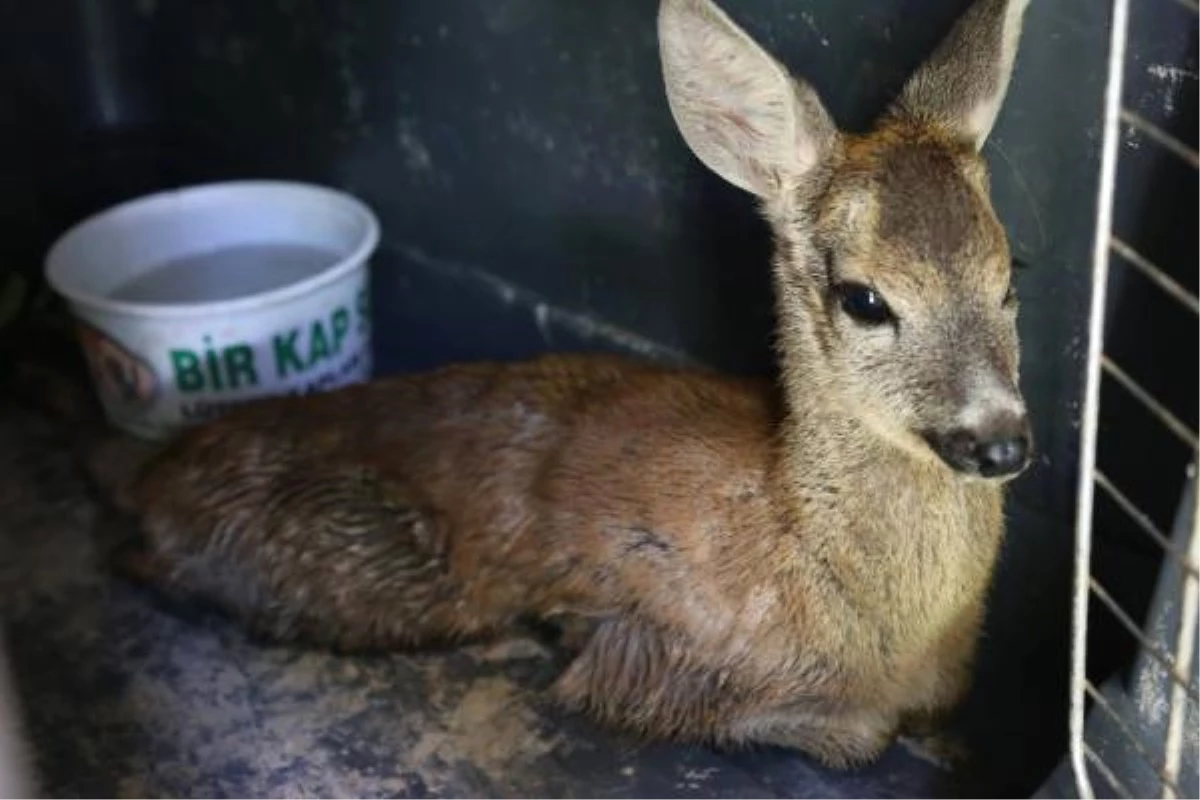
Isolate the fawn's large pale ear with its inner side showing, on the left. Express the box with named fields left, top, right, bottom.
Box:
left=659, top=0, right=838, bottom=198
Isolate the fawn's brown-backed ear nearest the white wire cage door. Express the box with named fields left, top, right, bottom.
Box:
left=888, top=0, right=1030, bottom=150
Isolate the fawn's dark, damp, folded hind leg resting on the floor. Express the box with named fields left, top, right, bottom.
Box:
left=114, top=465, right=506, bottom=650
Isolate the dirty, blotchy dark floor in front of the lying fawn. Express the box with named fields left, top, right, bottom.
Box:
left=0, top=408, right=947, bottom=800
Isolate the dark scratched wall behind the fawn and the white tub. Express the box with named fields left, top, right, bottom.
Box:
left=0, top=0, right=1156, bottom=787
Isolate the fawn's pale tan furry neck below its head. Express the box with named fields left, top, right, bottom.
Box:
left=773, top=367, right=1003, bottom=625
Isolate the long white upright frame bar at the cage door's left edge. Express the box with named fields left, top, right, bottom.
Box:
left=1070, top=0, right=1129, bottom=800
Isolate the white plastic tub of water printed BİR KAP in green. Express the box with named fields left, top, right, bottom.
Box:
left=46, top=181, right=379, bottom=439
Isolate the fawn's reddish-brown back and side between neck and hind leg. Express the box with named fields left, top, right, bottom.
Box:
left=138, top=355, right=778, bottom=626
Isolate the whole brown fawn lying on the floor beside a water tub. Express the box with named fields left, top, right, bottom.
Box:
left=75, top=0, right=1031, bottom=766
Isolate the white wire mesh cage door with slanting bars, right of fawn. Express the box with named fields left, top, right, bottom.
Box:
left=1070, top=0, right=1200, bottom=800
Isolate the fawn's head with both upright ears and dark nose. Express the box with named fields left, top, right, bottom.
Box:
left=659, top=0, right=1031, bottom=479
